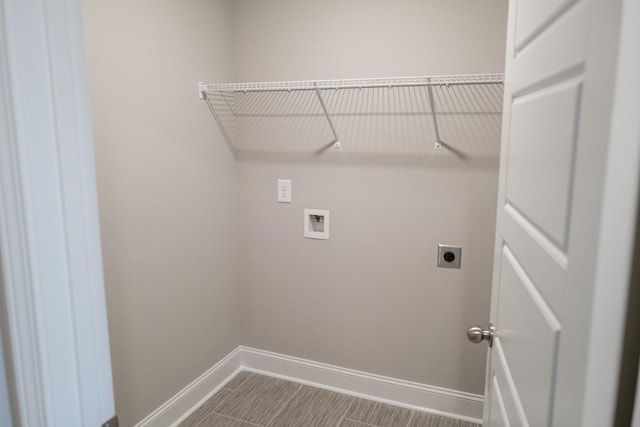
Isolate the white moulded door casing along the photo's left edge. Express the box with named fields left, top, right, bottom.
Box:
left=0, top=0, right=115, bottom=427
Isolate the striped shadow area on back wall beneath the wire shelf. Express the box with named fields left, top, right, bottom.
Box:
left=202, top=84, right=503, bottom=167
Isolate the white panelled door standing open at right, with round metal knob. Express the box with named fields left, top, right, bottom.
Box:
left=484, top=0, right=638, bottom=427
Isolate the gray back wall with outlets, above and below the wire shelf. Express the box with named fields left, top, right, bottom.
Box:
left=233, top=0, right=507, bottom=394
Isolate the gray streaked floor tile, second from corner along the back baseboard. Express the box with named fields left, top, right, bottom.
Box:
left=269, top=386, right=353, bottom=427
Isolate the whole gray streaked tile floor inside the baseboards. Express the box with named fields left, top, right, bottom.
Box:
left=180, top=371, right=479, bottom=427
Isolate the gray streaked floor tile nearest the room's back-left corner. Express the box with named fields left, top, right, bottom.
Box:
left=216, top=374, right=300, bottom=425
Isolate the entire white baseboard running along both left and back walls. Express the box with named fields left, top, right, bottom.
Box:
left=135, top=346, right=484, bottom=427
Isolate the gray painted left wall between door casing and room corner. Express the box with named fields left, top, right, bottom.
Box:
left=84, top=0, right=240, bottom=426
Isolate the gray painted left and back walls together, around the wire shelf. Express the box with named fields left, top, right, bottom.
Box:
left=84, top=0, right=506, bottom=425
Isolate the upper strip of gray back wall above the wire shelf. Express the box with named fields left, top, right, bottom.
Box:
left=233, top=0, right=508, bottom=82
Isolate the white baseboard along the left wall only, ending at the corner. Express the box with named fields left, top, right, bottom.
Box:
left=135, top=347, right=242, bottom=427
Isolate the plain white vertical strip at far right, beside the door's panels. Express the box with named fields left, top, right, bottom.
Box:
left=583, top=0, right=640, bottom=427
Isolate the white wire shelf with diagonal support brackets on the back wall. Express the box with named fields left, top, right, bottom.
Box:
left=199, top=73, right=504, bottom=157
